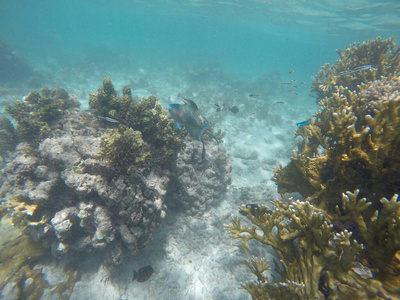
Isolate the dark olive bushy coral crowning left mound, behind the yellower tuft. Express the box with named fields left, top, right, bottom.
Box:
left=89, top=77, right=186, bottom=166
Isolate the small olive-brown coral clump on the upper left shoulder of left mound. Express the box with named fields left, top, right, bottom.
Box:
left=5, top=87, right=79, bottom=147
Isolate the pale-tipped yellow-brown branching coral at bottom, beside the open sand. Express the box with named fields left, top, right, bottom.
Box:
left=226, top=197, right=399, bottom=299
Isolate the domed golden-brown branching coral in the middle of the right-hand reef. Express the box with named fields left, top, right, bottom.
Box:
left=274, top=73, right=400, bottom=211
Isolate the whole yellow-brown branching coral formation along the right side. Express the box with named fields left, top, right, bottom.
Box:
left=227, top=38, right=400, bottom=299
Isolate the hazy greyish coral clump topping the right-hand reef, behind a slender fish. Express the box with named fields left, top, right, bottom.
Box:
left=311, top=37, right=400, bottom=102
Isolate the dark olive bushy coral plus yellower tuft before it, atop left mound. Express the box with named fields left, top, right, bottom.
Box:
left=89, top=77, right=186, bottom=168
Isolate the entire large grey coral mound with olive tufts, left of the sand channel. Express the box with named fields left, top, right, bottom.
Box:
left=0, top=78, right=230, bottom=270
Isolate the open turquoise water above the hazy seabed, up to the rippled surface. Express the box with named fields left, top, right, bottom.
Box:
left=0, top=0, right=400, bottom=82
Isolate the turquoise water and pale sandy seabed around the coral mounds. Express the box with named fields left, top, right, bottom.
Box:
left=0, top=0, right=400, bottom=300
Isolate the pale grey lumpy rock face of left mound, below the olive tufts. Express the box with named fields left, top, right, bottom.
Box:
left=0, top=110, right=169, bottom=265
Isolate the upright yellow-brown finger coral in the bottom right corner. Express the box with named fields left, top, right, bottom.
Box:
left=336, top=190, right=400, bottom=295
